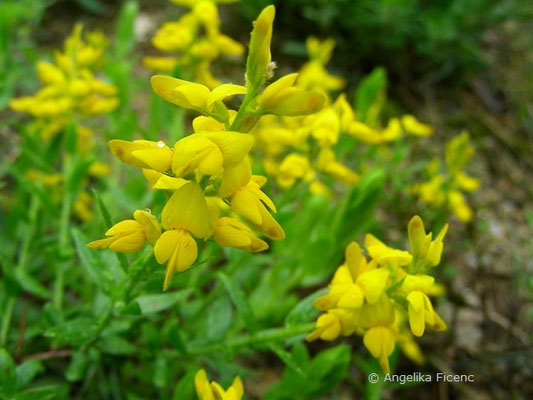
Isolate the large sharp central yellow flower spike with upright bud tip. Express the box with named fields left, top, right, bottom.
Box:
left=89, top=6, right=324, bottom=289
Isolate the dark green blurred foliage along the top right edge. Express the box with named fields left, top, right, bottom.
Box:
left=240, top=0, right=528, bottom=83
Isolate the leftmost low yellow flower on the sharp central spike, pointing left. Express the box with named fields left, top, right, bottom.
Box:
left=87, top=210, right=161, bottom=253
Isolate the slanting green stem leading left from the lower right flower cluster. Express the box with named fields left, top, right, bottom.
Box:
left=189, top=322, right=315, bottom=355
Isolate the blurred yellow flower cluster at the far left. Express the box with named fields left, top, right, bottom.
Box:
left=10, top=24, right=118, bottom=221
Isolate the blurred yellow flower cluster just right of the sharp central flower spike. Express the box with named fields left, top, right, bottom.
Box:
left=254, top=37, right=433, bottom=195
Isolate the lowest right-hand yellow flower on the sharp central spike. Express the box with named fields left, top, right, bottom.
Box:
left=213, top=217, right=268, bottom=253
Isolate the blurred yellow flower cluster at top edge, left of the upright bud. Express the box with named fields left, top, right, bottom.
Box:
left=143, top=0, right=244, bottom=88
